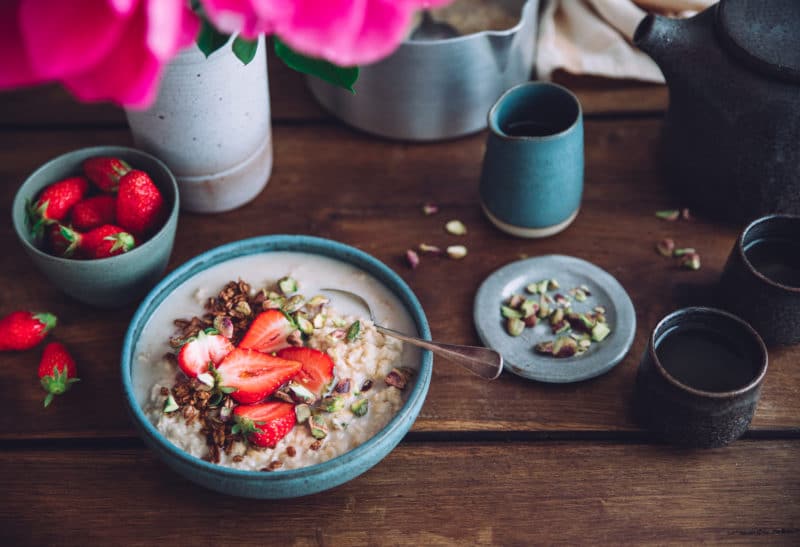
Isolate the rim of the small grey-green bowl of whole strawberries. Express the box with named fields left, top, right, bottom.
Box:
left=11, top=145, right=180, bottom=265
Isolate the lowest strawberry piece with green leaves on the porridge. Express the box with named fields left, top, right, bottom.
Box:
left=233, top=402, right=297, bottom=448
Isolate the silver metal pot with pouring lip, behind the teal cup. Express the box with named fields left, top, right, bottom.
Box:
left=307, top=0, right=539, bottom=141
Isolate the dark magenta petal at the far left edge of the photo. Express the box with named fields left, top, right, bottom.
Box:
left=0, top=1, right=44, bottom=89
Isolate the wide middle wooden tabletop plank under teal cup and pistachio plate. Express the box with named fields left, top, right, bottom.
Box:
left=0, top=119, right=800, bottom=438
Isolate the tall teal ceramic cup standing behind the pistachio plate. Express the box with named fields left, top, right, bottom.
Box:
left=480, top=82, right=583, bottom=237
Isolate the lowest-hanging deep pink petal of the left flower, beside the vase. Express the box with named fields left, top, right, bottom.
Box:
left=64, top=10, right=163, bottom=108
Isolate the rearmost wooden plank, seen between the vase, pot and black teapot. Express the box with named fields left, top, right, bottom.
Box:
left=0, top=52, right=667, bottom=127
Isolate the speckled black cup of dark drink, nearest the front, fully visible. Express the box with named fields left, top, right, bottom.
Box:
left=634, top=308, right=767, bottom=448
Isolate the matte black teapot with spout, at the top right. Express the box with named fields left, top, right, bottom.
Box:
left=634, top=0, right=800, bottom=221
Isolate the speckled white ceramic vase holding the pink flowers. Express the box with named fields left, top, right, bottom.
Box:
left=126, top=37, right=272, bottom=213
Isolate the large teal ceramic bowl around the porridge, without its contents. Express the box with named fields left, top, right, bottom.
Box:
left=122, top=235, right=433, bottom=499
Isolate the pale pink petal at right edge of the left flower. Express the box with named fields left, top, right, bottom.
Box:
left=145, top=0, right=200, bottom=60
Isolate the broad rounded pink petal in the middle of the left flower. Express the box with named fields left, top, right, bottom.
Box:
left=20, top=0, right=133, bottom=78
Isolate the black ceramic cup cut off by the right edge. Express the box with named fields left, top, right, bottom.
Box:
left=719, top=215, right=800, bottom=345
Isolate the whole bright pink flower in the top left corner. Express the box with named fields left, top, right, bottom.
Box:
left=0, top=0, right=199, bottom=107
